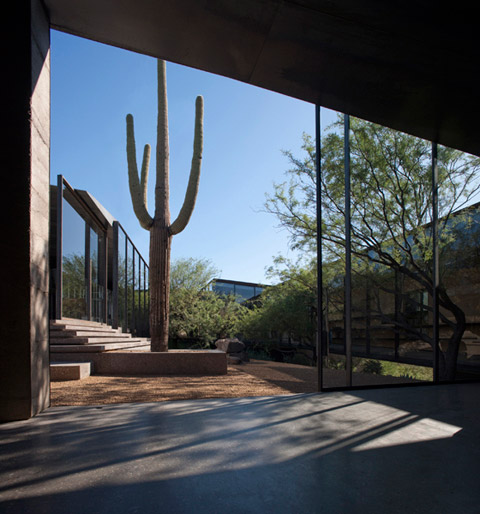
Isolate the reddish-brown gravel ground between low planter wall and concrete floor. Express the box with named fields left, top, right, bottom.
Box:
left=51, top=360, right=416, bottom=406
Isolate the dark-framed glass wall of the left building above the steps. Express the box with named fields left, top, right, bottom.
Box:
left=54, top=175, right=149, bottom=337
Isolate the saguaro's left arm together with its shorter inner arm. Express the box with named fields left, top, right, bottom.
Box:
left=127, top=114, right=153, bottom=230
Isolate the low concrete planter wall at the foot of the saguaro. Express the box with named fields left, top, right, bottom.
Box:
left=51, top=350, right=227, bottom=375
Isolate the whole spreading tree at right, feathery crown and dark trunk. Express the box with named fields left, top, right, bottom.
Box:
left=265, top=117, right=480, bottom=378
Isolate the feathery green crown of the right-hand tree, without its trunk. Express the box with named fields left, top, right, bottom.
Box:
left=265, top=117, right=480, bottom=266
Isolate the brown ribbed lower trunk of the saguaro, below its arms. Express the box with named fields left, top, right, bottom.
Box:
left=149, top=220, right=172, bottom=352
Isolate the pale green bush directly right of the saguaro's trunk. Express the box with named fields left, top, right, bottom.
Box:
left=169, top=259, right=246, bottom=347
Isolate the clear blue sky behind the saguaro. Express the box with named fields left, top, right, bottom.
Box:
left=51, top=31, right=334, bottom=282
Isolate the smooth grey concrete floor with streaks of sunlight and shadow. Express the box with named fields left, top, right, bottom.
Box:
left=0, top=384, right=480, bottom=514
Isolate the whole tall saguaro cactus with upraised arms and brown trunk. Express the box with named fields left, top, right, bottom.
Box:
left=127, top=60, right=203, bottom=352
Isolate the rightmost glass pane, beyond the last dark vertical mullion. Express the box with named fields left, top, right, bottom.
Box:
left=438, top=147, right=480, bottom=380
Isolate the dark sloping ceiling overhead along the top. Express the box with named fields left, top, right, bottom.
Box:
left=45, top=0, right=480, bottom=155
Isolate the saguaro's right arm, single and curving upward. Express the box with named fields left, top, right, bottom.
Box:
left=170, top=96, right=203, bottom=235
